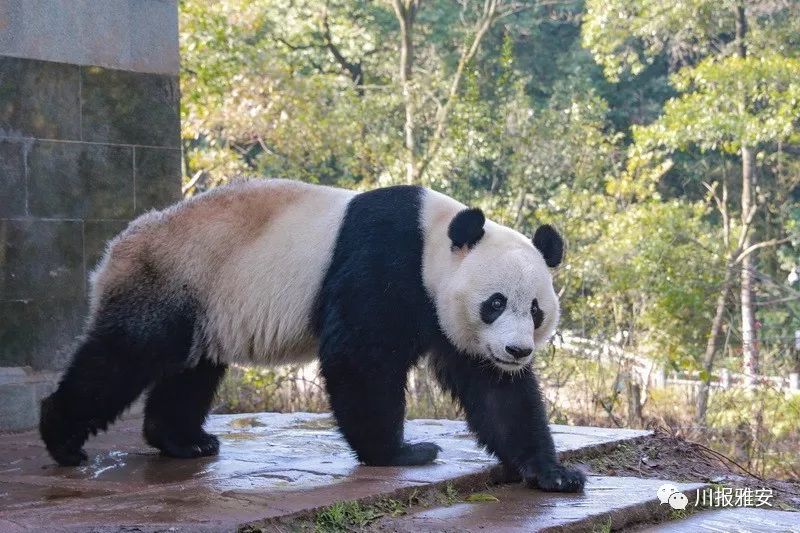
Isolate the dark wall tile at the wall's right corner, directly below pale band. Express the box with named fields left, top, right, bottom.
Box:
left=81, top=67, right=180, bottom=148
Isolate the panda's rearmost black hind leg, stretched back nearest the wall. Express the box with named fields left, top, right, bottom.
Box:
left=39, top=293, right=195, bottom=466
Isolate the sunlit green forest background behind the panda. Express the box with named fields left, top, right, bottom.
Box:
left=181, top=0, right=800, bottom=478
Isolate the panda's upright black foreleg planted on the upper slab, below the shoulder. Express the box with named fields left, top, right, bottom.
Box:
left=320, top=341, right=441, bottom=466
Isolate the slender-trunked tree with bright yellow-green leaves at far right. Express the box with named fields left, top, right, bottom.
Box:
left=584, top=0, right=800, bottom=417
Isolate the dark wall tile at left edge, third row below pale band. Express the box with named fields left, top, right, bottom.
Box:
left=0, top=219, right=85, bottom=302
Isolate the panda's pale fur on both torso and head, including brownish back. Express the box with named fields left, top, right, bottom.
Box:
left=90, top=180, right=558, bottom=371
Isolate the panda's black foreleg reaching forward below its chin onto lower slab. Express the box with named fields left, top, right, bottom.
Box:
left=431, top=348, right=586, bottom=492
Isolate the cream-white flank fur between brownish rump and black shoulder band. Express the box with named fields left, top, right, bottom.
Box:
left=207, top=182, right=354, bottom=365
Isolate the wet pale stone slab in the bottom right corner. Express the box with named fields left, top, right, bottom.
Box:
left=638, top=507, right=800, bottom=533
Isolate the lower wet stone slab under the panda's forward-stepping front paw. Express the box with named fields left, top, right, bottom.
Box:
left=375, top=476, right=704, bottom=533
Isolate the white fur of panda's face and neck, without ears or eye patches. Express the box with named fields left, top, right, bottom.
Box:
left=421, top=191, right=559, bottom=371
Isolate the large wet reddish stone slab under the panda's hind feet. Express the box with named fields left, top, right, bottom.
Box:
left=0, top=413, right=649, bottom=532
